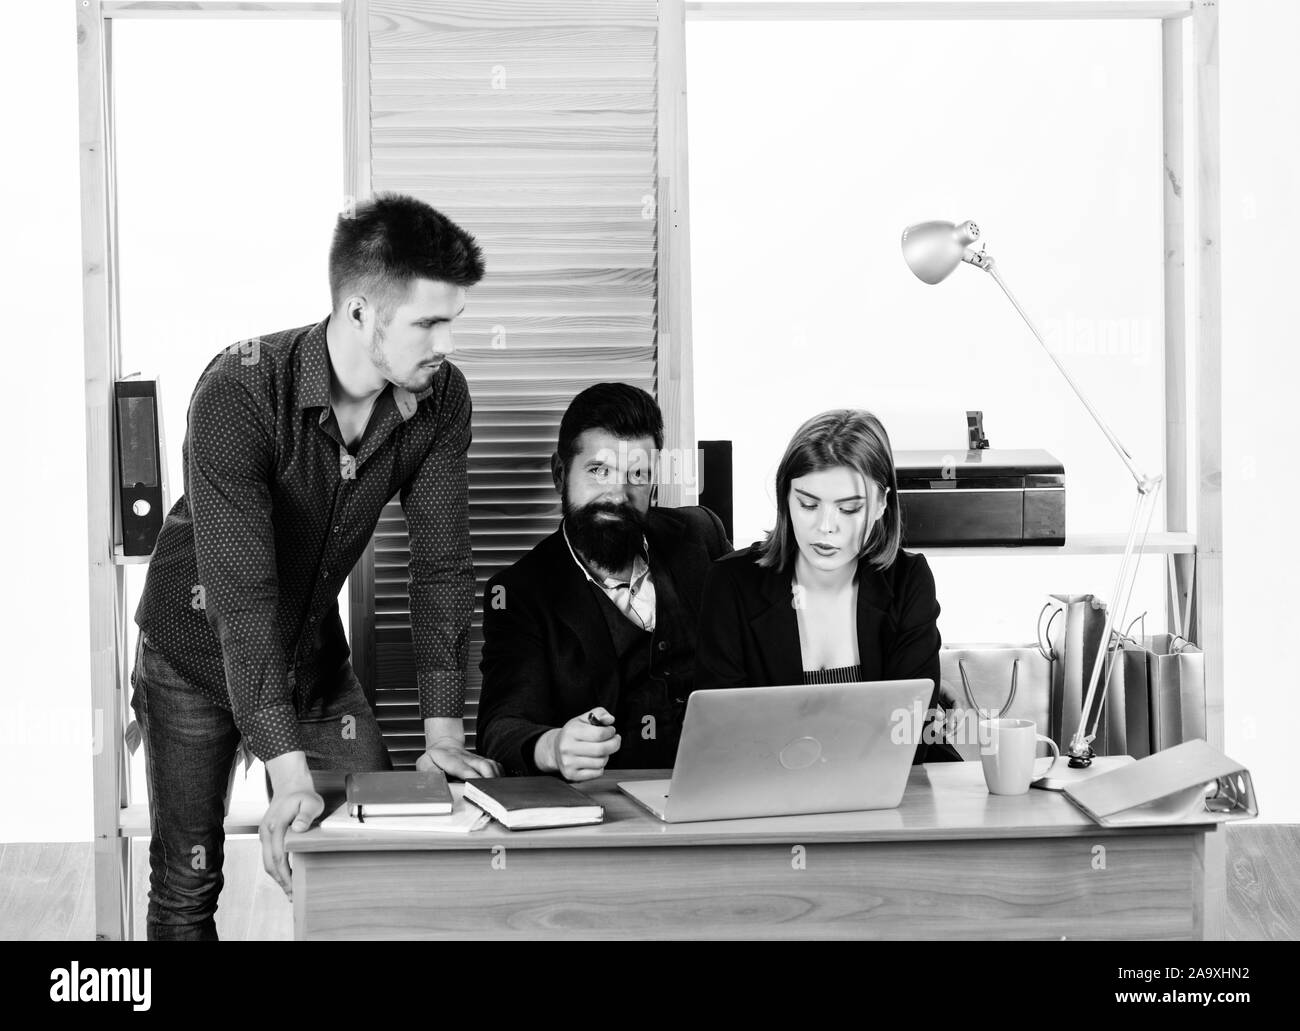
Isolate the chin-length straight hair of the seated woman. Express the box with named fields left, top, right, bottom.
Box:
left=758, top=408, right=902, bottom=569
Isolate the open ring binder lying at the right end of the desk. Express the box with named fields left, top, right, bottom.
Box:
left=1065, top=740, right=1260, bottom=827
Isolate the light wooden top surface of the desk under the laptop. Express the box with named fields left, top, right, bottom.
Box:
left=286, top=762, right=1214, bottom=853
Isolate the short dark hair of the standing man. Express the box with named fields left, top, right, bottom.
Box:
left=329, top=194, right=484, bottom=322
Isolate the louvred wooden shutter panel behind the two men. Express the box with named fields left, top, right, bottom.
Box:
left=359, top=0, right=659, bottom=767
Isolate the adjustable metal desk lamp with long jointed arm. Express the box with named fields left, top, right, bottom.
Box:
left=902, top=221, right=1165, bottom=790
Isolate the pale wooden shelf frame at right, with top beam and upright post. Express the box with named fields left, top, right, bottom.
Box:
left=685, top=0, right=1227, bottom=937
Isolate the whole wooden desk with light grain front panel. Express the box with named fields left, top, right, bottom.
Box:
left=289, top=762, right=1223, bottom=940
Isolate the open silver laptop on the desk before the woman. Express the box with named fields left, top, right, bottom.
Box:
left=619, top=680, right=935, bottom=823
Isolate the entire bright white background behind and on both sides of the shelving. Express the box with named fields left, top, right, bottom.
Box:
left=0, top=0, right=1300, bottom=841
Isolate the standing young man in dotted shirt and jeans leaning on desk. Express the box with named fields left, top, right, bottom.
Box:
left=131, top=194, right=499, bottom=940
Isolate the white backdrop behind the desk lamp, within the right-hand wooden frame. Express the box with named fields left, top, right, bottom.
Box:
left=686, top=14, right=1167, bottom=642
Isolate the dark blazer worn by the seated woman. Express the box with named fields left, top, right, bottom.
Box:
left=696, top=545, right=961, bottom=762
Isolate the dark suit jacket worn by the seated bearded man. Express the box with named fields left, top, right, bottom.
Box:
left=477, top=507, right=731, bottom=772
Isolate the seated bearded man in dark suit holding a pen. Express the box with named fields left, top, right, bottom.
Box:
left=478, top=384, right=731, bottom=780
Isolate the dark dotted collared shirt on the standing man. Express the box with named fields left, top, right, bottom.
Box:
left=135, top=319, right=475, bottom=759
